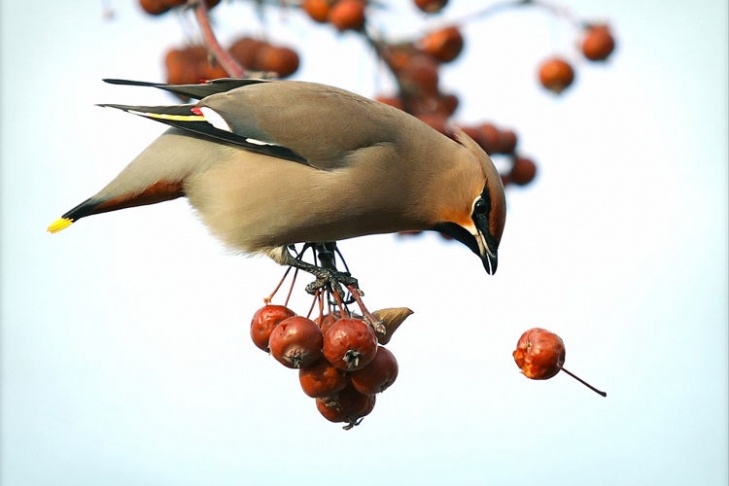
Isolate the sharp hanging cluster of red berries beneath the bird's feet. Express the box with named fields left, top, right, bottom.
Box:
left=251, top=304, right=412, bottom=429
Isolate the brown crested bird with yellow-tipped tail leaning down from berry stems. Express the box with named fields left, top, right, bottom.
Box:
left=48, top=78, right=506, bottom=285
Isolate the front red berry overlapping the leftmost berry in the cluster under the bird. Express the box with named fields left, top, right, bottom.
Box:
left=268, top=316, right=324, bottom=368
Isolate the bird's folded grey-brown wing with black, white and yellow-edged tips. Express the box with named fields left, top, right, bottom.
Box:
left=100, top=79, right=412, bottom=170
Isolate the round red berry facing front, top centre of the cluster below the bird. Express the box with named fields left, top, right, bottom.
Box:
left=323, top=318, right=377, bottom=371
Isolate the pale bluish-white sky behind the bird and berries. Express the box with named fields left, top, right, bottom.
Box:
left=0, top=0, right=729, bottom=486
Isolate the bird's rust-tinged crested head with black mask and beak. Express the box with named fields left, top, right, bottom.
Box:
left=434, top=129, right=506, bottom=275
